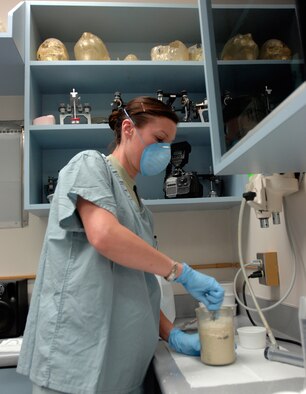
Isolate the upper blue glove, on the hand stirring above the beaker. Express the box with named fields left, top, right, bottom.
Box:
left=175, top=263, right=224, bottom=311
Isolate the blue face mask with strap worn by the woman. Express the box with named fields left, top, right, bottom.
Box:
left=124, top=109, right=171, bottom=176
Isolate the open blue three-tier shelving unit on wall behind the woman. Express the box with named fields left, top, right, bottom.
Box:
left=25, top=1, right=244, bottom=215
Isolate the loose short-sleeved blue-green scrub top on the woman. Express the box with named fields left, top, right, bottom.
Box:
left=17, top=151, right=160, bottom=394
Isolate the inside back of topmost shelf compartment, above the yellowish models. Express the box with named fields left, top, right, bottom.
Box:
left=29, top=1, right=200, bottom=43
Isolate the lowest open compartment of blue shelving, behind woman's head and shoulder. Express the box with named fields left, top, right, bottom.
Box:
left=25, top=122, right=215, bottom=215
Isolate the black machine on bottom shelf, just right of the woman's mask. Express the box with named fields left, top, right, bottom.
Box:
left=164, top=141, right=203, bottom=198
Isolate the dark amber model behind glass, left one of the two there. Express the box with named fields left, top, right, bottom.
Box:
left=221, top=33, right=259, bottom=60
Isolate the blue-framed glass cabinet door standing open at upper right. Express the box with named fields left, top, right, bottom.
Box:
left=199, top=0, right=306, bottom=174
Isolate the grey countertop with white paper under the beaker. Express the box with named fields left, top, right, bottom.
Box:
left=154, top=322, right=306, bottom=394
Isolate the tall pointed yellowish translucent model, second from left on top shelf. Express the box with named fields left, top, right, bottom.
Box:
left=74, top=32, right=110, bottom=60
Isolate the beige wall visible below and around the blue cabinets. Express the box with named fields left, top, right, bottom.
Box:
left=0, top=0, right=306, bottom=306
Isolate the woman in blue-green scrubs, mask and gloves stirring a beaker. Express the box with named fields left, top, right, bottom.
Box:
left=17, top=97, right=223, bottom=394
